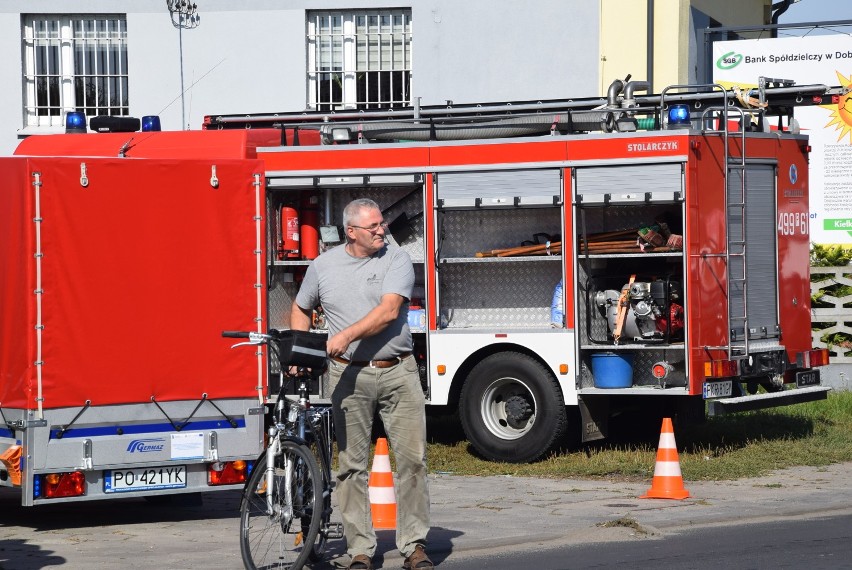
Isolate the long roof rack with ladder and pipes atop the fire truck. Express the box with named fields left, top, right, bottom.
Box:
left=203, top=77, right=848, bottom=143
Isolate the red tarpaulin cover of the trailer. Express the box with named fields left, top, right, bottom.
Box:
left=0, top=133, right=266, bottom=409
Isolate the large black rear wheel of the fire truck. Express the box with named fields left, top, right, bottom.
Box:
left=459, top=352, right=567, bottom=463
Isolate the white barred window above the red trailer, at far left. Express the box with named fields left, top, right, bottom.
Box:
left=22, top=15, right=130, bottom=127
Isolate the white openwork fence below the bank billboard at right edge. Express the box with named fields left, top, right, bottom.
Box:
left=811, top=266, right=852, bottom=364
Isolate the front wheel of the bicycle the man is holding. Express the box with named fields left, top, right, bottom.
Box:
left=240, top=440, right=322, bottom=570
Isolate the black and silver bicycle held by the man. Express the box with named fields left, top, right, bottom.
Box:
left=222, top=329, right=343, bottom=570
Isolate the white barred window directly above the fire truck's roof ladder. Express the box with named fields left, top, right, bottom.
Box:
left=307, top=9, right=411, bottom=111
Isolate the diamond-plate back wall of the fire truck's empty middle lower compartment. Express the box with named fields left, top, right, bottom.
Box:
left=439, top=259, right=562, bottom=328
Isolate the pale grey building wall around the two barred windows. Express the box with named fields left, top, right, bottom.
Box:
left=0, top=0, right=600, bottom=155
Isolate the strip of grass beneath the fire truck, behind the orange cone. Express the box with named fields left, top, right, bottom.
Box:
left=428, top=392, right=852, bottom=481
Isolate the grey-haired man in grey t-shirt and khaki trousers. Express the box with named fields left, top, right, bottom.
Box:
left=290, top=199, right=433, bottom=570
